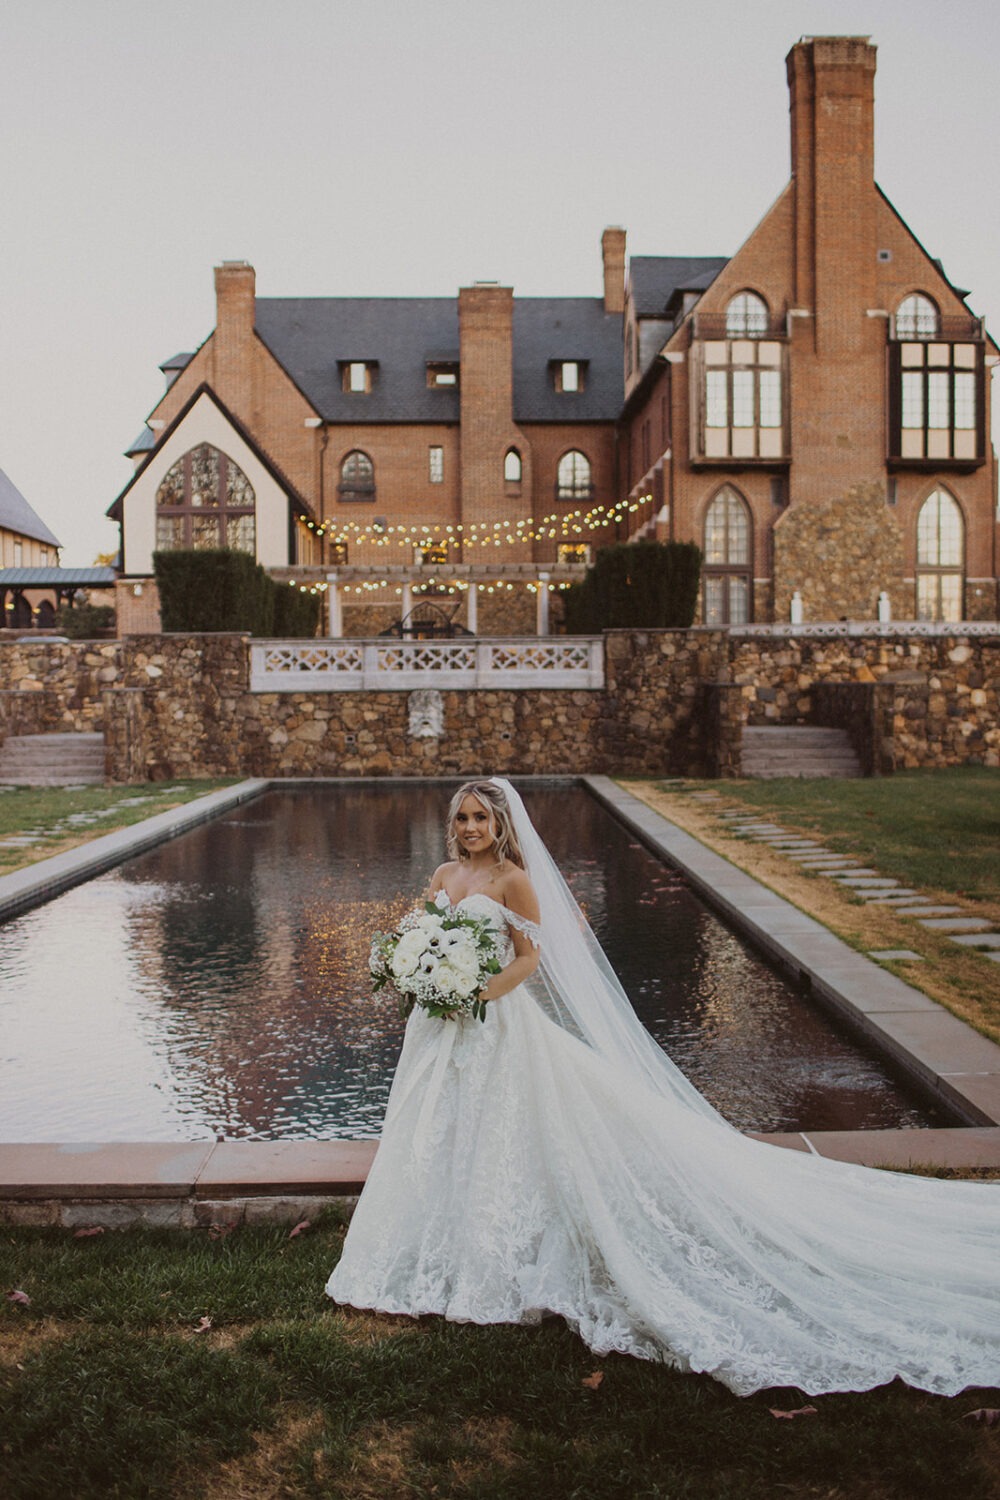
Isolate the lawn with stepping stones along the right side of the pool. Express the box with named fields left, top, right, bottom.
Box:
left=622, top=767, right=1000, bottom=1043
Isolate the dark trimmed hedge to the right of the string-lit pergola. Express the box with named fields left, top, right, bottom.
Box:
left=562, top=542, right=702, bottom=636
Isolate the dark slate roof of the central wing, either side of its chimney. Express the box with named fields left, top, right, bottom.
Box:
left=256, top=297, right=624, bottom=423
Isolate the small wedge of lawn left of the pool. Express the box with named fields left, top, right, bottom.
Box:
left=0, top=777, right=235, bottom=875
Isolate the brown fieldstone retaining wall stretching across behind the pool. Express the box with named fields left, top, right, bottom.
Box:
left=0, top=627, right=1000, bottom=782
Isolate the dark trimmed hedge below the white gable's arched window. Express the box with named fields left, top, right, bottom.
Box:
left=153, top=548, right=319, bottom=636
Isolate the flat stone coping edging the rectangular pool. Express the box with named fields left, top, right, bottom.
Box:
left=0, top=776, right=1000, bottom=1227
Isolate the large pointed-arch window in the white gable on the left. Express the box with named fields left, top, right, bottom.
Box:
left=156, top=443, right=256, bottom=554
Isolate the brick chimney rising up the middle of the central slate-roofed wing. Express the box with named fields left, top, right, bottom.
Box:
left=459, top=282, right=531, bottom=561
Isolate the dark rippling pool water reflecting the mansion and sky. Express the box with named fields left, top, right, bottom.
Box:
left=0, top=783, right=934, bottom=1140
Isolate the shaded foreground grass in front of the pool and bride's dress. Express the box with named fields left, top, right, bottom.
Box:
left=0, top=1215, right=1000, bottom=1500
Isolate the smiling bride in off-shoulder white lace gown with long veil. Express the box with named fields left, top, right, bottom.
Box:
left=327, top=780, right=1000, bottom=1395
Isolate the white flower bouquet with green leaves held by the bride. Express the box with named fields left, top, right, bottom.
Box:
left=369, top=902, right=501, bottom=1022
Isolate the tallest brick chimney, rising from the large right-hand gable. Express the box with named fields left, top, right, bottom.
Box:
left=786, top=36, right=876, bottom=353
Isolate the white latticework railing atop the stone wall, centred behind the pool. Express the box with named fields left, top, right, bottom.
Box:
left=250, top=636, right=604, bottom=693
